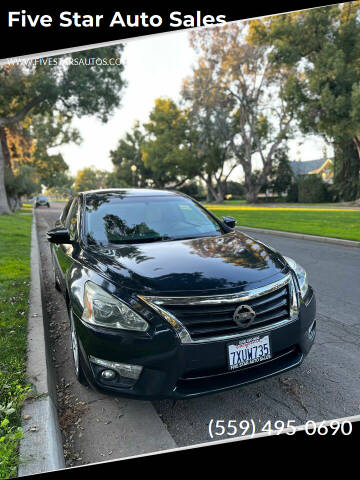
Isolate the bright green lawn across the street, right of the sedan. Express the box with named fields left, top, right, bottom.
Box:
left=208, top=207, right=360, bottom=241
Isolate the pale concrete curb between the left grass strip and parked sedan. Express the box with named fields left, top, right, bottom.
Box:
left=18, top=217, right=65, bottom=477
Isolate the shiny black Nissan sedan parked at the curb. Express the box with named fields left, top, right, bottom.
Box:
left=48, top=189, right=316, bottom=399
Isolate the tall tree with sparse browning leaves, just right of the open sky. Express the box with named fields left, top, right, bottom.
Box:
left=184, top=22, right=293, bottom=202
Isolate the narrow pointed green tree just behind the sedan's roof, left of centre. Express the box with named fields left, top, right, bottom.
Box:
left=108, top=122, right=152, bottom=187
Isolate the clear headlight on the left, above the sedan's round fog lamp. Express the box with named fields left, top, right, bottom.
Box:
left=81, top=282, right=149, bottom=332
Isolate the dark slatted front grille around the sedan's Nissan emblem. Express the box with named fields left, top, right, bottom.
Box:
left=161, top=284, right=290, bottom=341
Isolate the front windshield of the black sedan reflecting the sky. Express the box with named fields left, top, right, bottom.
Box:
left=85, top=195, right=222, bottom=246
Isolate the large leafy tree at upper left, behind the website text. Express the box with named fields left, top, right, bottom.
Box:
left=0, top=45, right=125, bottom=214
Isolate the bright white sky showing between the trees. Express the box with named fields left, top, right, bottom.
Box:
left=51, top=26, right=331, bottom=180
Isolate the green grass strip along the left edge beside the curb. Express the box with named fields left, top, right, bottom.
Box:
left=0, top=213, right=32, bottom=479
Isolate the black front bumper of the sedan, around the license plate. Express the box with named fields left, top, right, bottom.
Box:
left=75, top=287, right=316, bottom=400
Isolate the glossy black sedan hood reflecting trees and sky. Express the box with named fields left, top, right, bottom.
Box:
left=86, top=232, right=287, bottom=295
